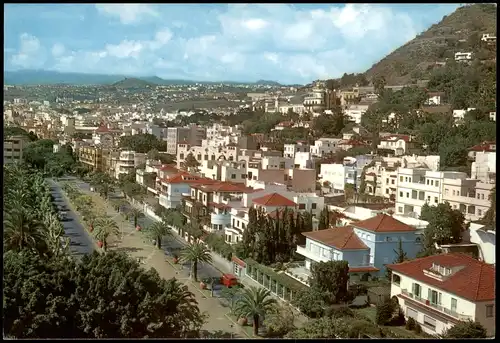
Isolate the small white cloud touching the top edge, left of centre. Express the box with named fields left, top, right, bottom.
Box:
left=95, top=4, right=159, bottom=25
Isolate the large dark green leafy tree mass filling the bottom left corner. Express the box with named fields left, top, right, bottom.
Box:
left=3, top=252, right=204, bottom=339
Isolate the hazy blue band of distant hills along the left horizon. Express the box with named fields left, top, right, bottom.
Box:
left=4, top=69, right=286, bottom=88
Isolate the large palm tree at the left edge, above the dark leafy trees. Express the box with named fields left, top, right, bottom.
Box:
left=3, top=208, right=46, bottom=253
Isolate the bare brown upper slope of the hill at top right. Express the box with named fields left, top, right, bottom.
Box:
left=365, top=4, right=497, bottom=85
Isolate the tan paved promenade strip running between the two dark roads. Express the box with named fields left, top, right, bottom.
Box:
left=69, top=185, right=247, bottom=338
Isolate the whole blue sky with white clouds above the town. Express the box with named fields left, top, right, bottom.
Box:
left=4, top=4, right=458, bottom=83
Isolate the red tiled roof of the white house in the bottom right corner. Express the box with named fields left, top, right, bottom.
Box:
left=387, top=253, right=495, bottom=301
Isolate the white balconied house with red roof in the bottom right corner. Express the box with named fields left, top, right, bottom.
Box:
left=387, top=253, right=495, bottom=336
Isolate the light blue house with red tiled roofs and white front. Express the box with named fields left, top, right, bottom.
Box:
left=297, top=213, right=422, bottom=276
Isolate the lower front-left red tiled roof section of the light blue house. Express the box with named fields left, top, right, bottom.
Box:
left=302, top=226, right=368, bottom=250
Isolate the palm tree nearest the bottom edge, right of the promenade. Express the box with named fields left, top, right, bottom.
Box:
left=235, top=287, right=276, bottom=336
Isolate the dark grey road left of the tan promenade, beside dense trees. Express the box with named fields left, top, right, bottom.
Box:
left=47, top=179, right=95, bottom=258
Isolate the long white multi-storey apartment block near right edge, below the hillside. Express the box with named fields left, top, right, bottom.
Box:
left=396, top=168, right=495, bottom=221
